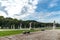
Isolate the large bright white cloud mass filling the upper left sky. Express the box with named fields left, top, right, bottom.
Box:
left=0, top=0, right=38, bottom=19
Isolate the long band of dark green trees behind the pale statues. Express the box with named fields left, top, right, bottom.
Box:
left=0, top=16, right=60, bottom=29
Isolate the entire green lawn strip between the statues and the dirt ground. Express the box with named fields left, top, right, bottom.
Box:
left=0, top=28, right=52, bottom=37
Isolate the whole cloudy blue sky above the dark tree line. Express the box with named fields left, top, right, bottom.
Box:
left=0, top=0, right=60, bottom=23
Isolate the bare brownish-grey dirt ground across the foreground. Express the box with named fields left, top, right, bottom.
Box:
left=0, top=30, right=60, bottom=40
